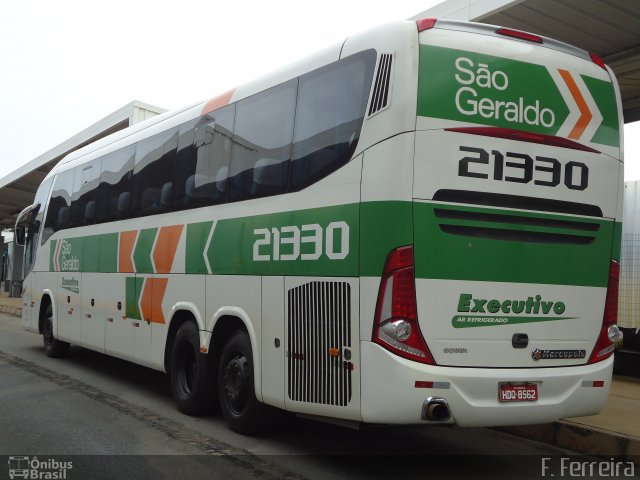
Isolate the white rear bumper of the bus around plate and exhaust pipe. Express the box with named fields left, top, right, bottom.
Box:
left=361, top=342, right=613, bottom=427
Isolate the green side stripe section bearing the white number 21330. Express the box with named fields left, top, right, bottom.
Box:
left=210, top=204, right=360, bottom=277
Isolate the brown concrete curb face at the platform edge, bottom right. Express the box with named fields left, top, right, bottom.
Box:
left=498, top=420, right=640, bottom=466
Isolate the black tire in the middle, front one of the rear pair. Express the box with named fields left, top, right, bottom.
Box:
left=169, top=322, right=216, bottom=416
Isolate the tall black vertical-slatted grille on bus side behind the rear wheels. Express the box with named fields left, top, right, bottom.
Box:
left=287, top=282, right=353, bottom=406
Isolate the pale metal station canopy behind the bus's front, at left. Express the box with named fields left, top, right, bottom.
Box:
left=0, top=101, right=165, bottom=229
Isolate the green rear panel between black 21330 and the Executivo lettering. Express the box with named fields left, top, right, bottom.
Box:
left=414, top=203, right=615, bottom=287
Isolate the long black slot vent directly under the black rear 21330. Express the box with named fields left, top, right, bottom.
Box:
left=433, top=190, right=602, bottom=217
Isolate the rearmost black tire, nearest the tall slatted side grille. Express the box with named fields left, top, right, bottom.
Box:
left=218, top=331, right=275, bottom=435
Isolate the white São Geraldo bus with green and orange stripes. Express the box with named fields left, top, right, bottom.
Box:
left=16, top=19, right=623, bottom=433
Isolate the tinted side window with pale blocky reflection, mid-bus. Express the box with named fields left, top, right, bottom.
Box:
left=176, top=105, right=235, bottom=208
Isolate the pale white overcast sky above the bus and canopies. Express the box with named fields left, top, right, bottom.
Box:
left=0, top=0, right=640, bottom=180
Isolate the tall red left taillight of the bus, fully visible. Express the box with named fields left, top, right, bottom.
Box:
left=372, top=246, right=435, bottom=365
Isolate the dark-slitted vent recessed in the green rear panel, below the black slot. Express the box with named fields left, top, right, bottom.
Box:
left=434, top=208, right=600, bottom=245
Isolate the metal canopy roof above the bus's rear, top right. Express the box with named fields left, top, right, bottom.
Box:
left=414, top=0, right=640, bottom=123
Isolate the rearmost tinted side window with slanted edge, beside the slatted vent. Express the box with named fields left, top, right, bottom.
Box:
left=291, top=50, right=376, bottom=190
